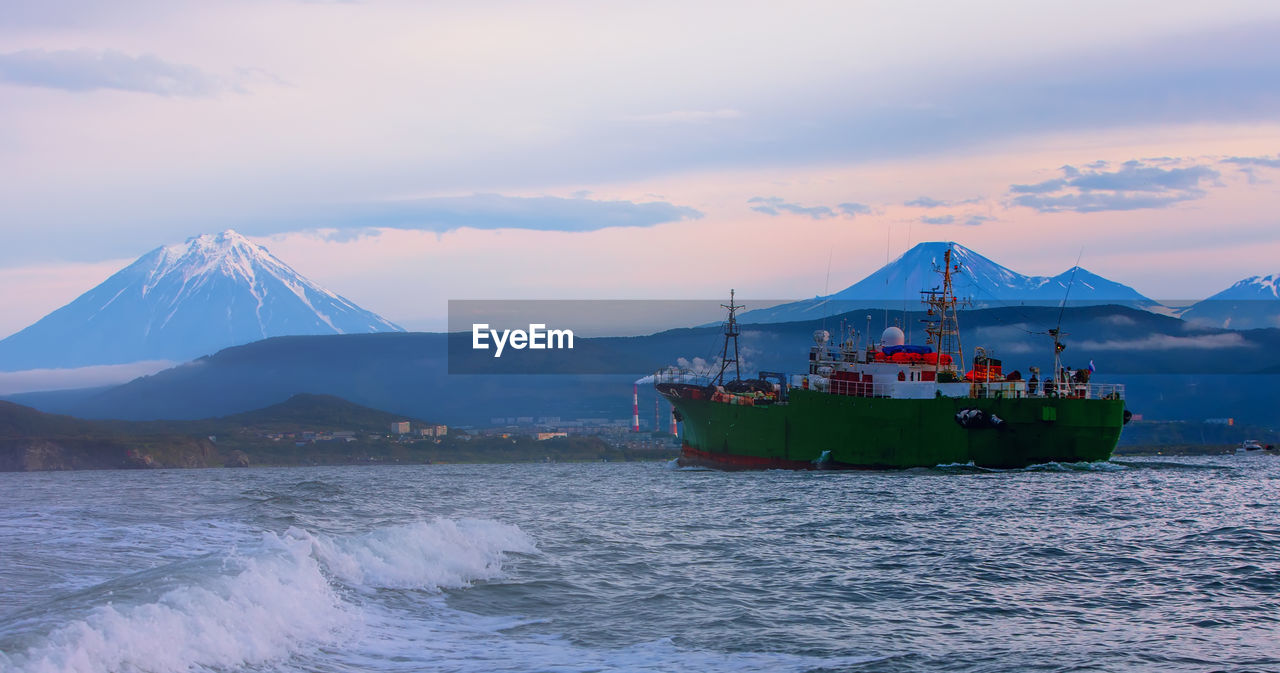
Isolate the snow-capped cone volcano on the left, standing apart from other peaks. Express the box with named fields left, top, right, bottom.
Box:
left=0, top=230, right=403, bottom=371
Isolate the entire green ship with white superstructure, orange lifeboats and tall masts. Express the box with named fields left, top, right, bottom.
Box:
left=654, top=251, right=1130, bottom=470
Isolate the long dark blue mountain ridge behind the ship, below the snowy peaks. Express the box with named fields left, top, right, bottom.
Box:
left=10, top=306, right=1280, bottom=426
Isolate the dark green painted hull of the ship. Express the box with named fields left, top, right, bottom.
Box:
left=667, top=389, right=1124, bottom=468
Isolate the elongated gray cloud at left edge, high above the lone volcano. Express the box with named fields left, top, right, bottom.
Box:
left=0, top=49, right=221, bottom=96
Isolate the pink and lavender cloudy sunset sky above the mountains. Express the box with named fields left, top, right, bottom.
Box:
left=0, top=0, right=1280, bottom=337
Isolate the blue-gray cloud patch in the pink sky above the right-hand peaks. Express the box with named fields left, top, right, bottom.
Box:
left=1009, top=160, right=1220, bottom=212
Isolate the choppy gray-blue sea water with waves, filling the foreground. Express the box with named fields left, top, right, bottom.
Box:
left=0, top=457, right=1280, bottom=673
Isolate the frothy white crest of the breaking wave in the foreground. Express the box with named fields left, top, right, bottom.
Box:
left=0, top=519, right=535, bottom=673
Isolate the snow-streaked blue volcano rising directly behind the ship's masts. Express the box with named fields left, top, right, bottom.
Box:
left=742, top=241, right=1158, bottom=322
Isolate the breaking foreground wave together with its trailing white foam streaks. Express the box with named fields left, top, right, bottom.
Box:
left=0, top=519, right=873, bottom=673
